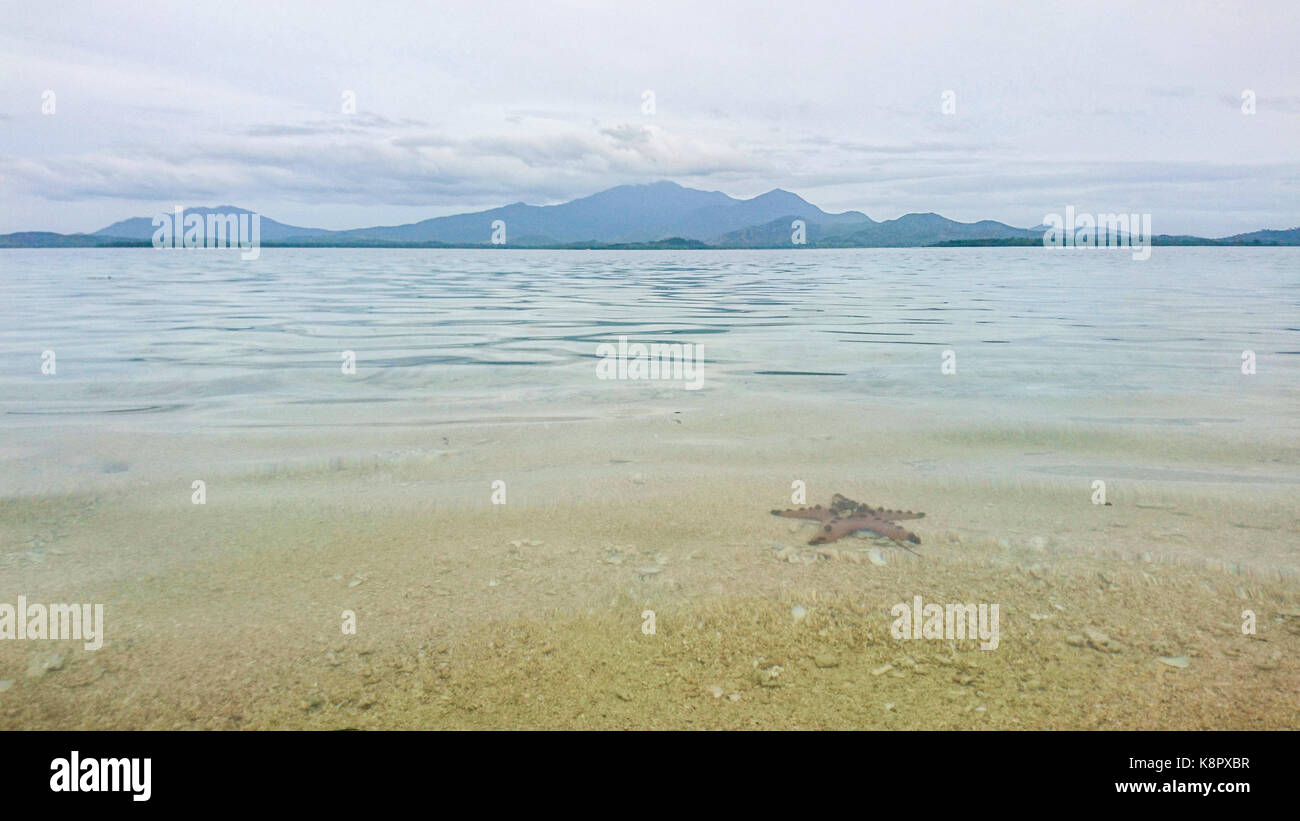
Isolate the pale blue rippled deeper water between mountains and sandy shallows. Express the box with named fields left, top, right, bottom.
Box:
left=0, top=248, right=1300, bottom=435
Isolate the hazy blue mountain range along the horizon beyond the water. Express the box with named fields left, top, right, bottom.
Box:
left=0, top=182, right=1300, bottom=251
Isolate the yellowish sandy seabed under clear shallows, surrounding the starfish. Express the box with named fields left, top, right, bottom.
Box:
left=0, top=392, right=1300, bottom=729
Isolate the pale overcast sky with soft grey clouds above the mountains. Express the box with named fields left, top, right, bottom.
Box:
left=0, top=0, right=1300, bottom=236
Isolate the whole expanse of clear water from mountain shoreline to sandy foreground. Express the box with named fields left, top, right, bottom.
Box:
left=0, top=248, right=1300, bottom=726
